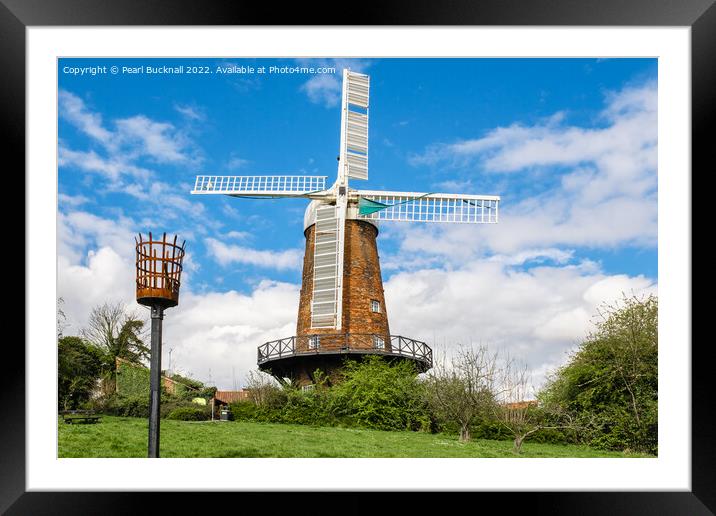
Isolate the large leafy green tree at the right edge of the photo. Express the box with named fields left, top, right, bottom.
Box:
left=540, top=295, right=658, bottom=453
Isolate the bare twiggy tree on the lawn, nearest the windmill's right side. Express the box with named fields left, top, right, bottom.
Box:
left=426, top=346, right=497, bottom=441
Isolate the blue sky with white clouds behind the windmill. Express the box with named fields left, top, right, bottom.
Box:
left=58, top=58, right=657, bottom=388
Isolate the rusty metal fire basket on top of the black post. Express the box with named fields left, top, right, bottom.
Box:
left=134, top=232, right=186, bottom=308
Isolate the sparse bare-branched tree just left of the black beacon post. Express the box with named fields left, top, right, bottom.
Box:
left=82, top=302, right=149, bottom=392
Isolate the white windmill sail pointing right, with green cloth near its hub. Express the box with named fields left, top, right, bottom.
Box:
left=352, top=190, right=500, bottom=224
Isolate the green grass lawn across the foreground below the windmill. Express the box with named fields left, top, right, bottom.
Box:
left=58, top=416, right=648, bottom=458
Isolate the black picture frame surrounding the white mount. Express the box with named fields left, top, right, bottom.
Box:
left=0, top=0, right=716, bottom=515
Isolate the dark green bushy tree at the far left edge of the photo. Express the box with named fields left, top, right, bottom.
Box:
left=57, top=337, right=103, bottom=410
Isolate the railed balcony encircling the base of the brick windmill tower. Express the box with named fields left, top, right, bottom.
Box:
left=258, top=333, right=433, bottom=373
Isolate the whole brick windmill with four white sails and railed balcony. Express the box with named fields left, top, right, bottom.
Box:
left=191, top=69, right=500, bottom=388
